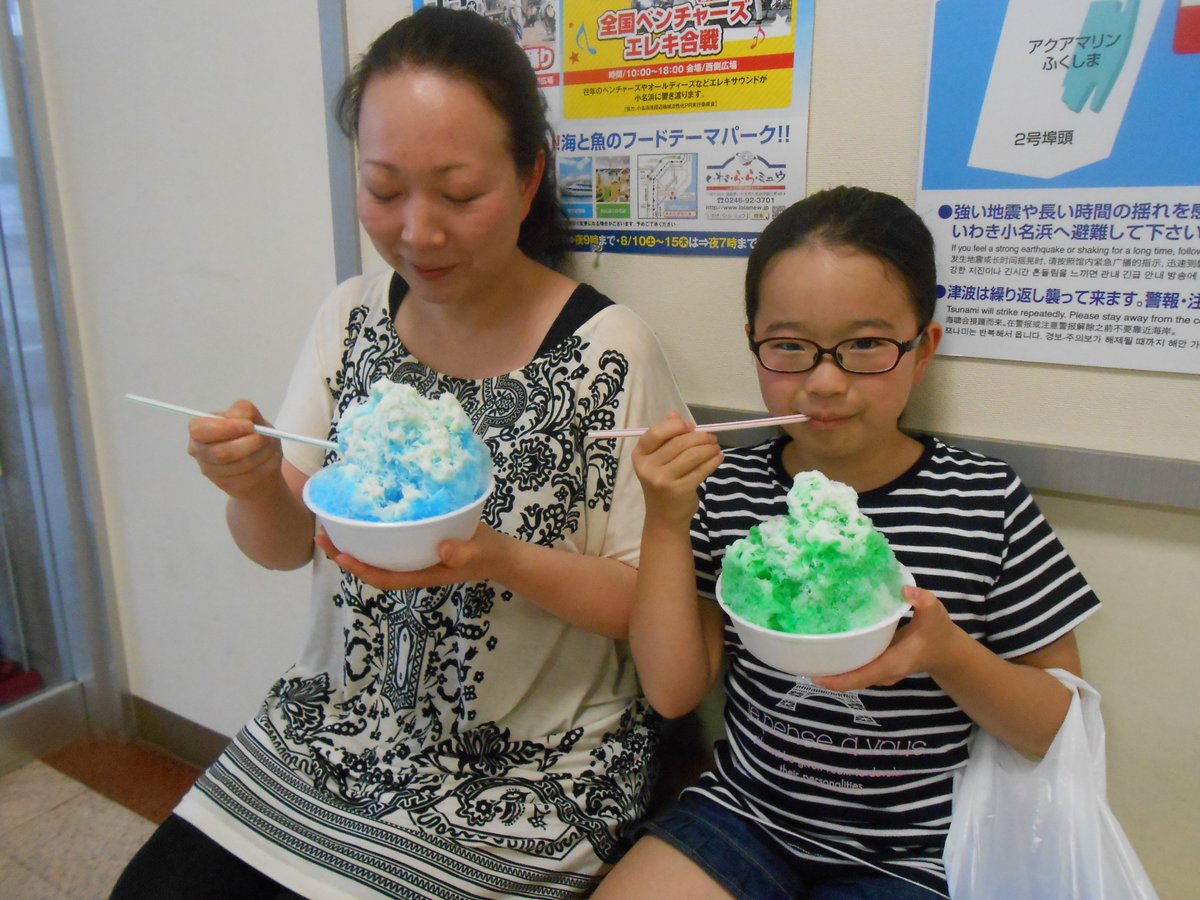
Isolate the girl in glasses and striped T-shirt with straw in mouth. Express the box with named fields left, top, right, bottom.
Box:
left=596, top=187, right=1098, bottom=900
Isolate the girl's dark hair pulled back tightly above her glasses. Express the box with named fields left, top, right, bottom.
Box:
left=745, top=186, right=937, bottom=328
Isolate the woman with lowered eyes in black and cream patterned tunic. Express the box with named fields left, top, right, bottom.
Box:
left=115, top=7, right=683, bottom=896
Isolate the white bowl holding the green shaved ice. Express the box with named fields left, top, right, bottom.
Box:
left=716, top=569, right=916, bottom=676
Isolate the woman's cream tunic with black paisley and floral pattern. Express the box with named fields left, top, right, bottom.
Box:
left=176, top=274, right=684, bottom=898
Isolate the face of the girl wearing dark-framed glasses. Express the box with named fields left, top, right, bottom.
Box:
left=748, top=242, right=942, bottom=474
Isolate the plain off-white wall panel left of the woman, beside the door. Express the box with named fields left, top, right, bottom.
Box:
left=26, top=0, right=334, bottom=734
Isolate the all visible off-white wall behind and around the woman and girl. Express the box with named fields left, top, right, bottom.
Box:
left=25, top=0, right=1200, bottom=899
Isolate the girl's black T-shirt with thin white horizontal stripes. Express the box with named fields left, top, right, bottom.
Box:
left=690, top=438, right=1099, bottom=892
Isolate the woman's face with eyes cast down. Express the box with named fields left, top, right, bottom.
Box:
left=358, top=67, right=544, bottom=304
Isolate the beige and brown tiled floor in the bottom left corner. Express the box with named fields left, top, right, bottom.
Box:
left=0, top=742, right=198, bottom=900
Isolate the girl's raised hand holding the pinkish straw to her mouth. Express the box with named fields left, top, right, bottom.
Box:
left=634, top=413, right=724, bottom=526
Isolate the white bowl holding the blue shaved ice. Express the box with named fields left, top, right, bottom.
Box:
left=304, top=479, right=492, bottom=572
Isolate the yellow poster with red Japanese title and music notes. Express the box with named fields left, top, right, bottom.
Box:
left=562, top=0, right=796, bottom=119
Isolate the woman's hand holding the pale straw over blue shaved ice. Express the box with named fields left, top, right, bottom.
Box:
left=187, top=400, right=283, bottom=499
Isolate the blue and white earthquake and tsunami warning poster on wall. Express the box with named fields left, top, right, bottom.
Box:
left=917, top=0, right=1200, bottom=373
